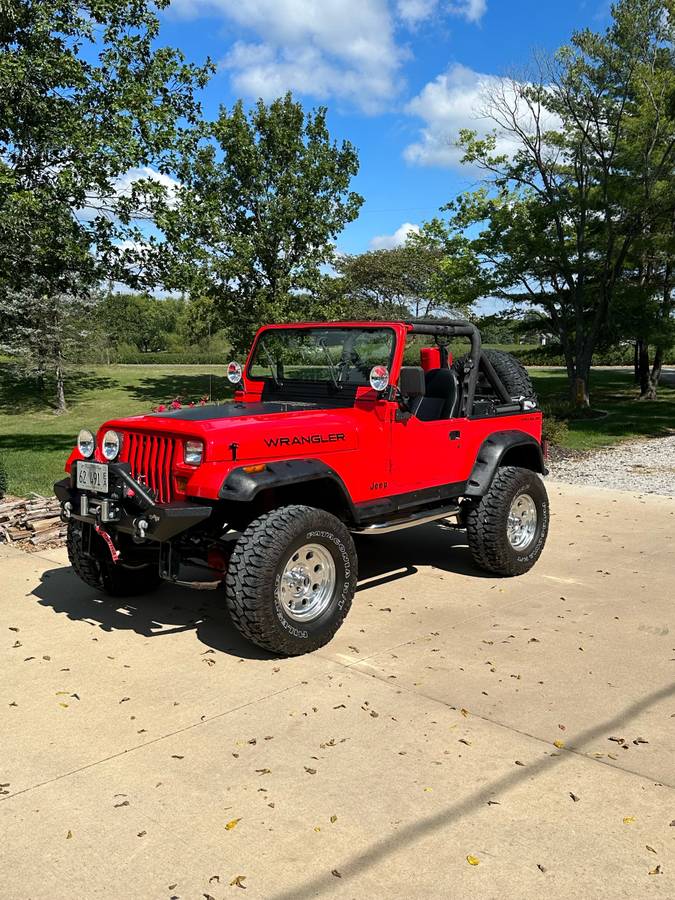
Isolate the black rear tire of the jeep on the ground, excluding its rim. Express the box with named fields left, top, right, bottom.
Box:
left=466, top=466, right=550, bottom=576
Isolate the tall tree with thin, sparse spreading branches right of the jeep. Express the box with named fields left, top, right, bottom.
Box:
left=430, top=0, right=675, bottom=405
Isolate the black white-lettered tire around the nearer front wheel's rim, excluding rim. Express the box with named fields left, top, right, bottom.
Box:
left=225, top=506, right=358, bottom=656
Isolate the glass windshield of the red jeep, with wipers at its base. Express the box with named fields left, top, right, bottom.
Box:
left=248, top=326, right=395, bottom=387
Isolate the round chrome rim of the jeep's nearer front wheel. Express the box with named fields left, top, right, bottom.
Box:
left=279, top=544, right=336, bottom=622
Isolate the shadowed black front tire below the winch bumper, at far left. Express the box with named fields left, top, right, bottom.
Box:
left=66, top=520, right=162, bottom=597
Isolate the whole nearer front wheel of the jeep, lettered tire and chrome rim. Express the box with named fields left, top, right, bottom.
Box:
left=225, top=506, right=357, bottom=656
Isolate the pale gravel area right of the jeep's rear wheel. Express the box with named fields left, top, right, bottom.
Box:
left=549, top=435, right=675, bottom=497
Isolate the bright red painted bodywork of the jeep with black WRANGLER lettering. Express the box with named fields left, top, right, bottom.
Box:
left=66, top=322, right=542, bottom=504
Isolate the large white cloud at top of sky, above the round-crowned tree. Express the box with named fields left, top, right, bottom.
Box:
left=171, top=0, right=406, bottom=112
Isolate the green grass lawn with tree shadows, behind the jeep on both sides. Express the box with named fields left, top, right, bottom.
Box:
left=0, top=363, right=675, bottom=495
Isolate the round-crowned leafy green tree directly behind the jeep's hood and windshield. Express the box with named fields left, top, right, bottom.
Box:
left=155, top=94, right=363, bottom=351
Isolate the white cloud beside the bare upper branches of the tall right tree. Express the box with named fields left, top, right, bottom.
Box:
left=404, top=64, right=558, bottom=167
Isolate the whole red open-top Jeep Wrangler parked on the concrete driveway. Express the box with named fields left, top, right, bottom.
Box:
left=55, top=320, right=549, bottom=655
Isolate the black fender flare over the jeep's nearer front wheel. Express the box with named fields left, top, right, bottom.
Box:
left=218, top=459, right=354, bottom=513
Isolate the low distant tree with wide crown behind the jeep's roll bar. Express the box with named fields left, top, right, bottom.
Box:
left=330, top=231, right=479, bottom=318
